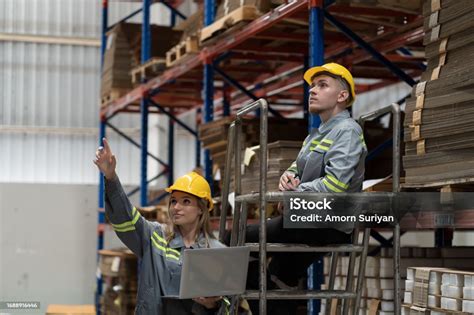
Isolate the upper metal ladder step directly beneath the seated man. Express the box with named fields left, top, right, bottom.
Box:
left=245, top=243, right=363, bottom=253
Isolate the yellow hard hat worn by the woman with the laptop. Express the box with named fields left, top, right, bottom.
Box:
left=165, top=172, right=214, bottom=210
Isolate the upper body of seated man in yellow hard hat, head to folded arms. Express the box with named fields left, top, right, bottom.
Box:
left=279, top=63, right=367, bottom=192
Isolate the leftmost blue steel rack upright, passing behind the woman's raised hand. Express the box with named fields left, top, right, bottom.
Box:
left=95, top=0, right=108, bottom=315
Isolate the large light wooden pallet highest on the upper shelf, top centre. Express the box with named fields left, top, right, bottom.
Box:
left=201, top=5, right=261, bottom=43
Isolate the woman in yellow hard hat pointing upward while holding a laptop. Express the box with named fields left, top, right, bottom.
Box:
left=94, top=138, right=229, bottom=315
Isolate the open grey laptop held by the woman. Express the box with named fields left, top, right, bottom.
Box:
left=165, top=246, right=250, bottom=299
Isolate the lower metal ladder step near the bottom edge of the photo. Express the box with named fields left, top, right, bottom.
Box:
left=242, top=290, right=356, bottom=300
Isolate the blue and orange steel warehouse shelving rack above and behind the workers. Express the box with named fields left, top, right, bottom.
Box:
left=96, top=0, right=430, bottom=314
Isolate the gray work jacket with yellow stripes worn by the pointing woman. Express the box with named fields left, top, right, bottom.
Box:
left=105, top=178, right=228, bottom=315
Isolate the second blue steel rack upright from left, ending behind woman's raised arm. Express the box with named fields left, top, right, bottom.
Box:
left=140, top=0, right=151, bottom=206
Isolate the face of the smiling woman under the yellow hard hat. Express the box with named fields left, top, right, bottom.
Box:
left=169, top=191, right=202, bottom=225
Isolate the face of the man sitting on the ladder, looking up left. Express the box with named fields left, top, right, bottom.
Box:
left=309, top=75, right=347, bottom=114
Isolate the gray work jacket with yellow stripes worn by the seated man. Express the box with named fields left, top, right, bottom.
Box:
left=288, top=110, right=367, bottom=192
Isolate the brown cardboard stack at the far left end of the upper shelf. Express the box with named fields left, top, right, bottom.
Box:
left=101, top=23, right=181, bottom=105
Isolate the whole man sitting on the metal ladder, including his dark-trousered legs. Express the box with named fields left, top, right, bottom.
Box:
left=241, top=63, right=367, bottom=314
